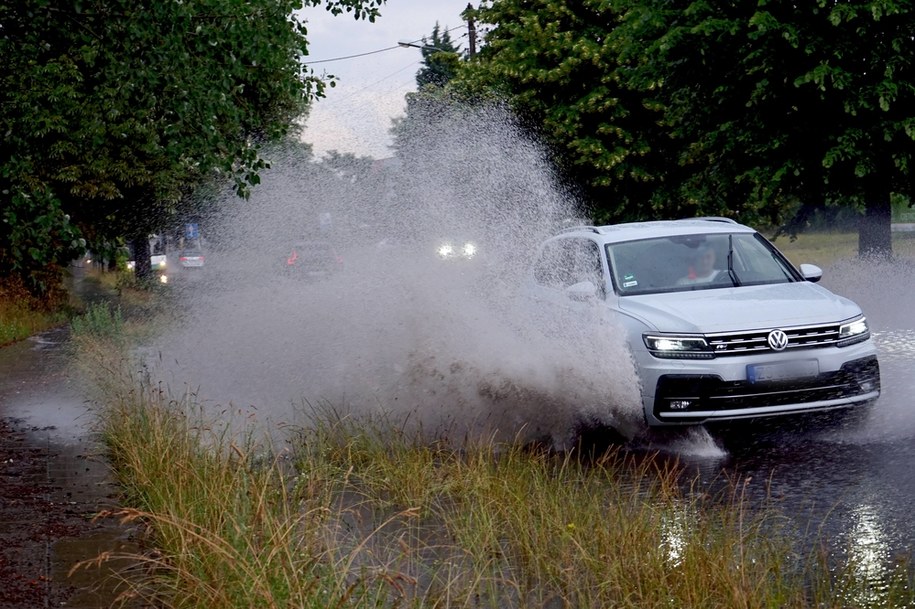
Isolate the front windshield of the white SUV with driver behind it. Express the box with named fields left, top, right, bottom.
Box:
left=607, top=233, right=802, bottom=296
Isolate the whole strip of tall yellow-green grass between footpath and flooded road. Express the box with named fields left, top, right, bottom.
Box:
left=72, top=304, right=915, bottom=609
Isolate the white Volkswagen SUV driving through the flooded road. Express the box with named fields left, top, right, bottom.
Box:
left=526, top=218, right=880, bottom=426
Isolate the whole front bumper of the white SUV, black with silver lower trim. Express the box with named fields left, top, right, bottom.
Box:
left=643, top=350, right=880, bottom=425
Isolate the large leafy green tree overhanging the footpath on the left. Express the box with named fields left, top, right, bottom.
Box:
left=0, top=0, right=383, bottom=293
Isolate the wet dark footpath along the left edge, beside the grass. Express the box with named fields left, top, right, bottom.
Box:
left=0, top=329, right=135, bottom=609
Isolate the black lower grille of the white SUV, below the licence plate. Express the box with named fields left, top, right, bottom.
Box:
left=654, top=356, right=880, bottom=419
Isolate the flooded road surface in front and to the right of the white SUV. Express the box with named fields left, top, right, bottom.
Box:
left=664, top=261, right=915, bottom=577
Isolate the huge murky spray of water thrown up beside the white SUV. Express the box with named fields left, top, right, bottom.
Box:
left=157, top=103, right=642, bottom=447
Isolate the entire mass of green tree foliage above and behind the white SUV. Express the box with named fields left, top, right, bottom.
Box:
left=460, top=0, right=915, bottom=253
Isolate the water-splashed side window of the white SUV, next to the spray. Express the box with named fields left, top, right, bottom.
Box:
left=534, top=238, right=604, bottom=291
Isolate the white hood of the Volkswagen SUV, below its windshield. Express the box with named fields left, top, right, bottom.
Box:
left=619, top=281, right=861, bottom=333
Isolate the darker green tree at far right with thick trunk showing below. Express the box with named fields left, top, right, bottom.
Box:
left=618, top=0, right=915, bottom=256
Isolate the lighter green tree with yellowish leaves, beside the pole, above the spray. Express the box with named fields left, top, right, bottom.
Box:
left=452, top=0, right=676, bottom=221
